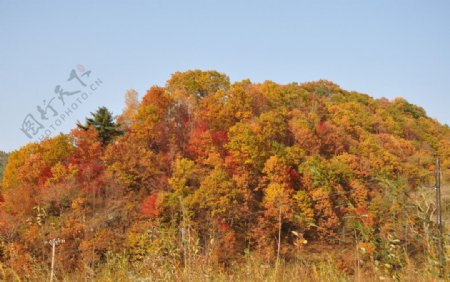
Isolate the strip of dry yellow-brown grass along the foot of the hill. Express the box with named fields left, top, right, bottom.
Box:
left=0, top=249, right=444, bottom=282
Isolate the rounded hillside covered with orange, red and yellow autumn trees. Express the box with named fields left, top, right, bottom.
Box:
left=0, top=70, right=450, bottom=280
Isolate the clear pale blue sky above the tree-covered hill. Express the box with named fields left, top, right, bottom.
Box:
left=0, top=0, right=450, bottom=151
